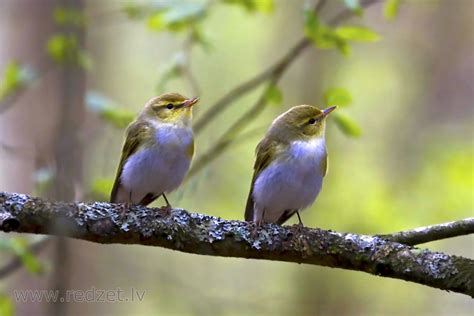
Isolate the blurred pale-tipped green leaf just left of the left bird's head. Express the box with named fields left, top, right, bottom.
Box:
left=86, top=91, right=135, bottom=129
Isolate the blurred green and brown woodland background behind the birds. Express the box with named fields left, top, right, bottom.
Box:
left=0, top=0, right=474, bottom=315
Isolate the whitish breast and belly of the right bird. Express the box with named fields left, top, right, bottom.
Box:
left=253, top=138, right=326, bottom=222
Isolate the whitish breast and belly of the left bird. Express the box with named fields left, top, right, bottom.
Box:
left=121, top=124, right=193, bottom=203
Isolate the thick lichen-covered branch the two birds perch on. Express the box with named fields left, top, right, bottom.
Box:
left=0, top=193, right=474, bottom=297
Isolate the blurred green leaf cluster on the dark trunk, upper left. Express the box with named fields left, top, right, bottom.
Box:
left=46, top=34, right=91, bottom=68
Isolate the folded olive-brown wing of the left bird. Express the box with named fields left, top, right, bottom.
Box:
left=110, top=122, right=153, bottom=203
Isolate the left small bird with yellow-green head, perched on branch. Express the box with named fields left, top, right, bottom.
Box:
left=110, top=93, right=199, bottom=209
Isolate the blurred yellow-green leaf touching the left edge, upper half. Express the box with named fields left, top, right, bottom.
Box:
left=0, top=61, right=36, bottom=101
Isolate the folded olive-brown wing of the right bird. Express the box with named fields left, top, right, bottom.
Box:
left=245, top=139, right=279, bottom=222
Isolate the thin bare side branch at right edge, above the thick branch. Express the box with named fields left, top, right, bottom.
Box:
left=379, top=217, right=474, bottom=246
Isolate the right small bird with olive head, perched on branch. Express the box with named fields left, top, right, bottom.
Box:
left=245, top=105, right=336, bottom=226
